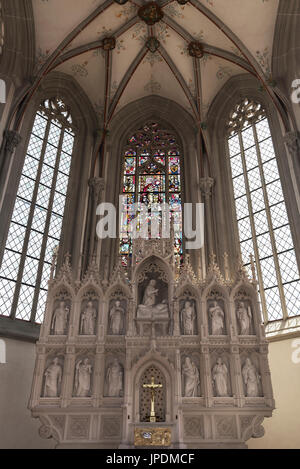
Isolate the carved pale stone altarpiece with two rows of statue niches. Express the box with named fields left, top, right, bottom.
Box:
left=29, top=240, right=274, bottom=449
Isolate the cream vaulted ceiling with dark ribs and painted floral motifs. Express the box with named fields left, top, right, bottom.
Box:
left=33, top=0, right=279, bottom=126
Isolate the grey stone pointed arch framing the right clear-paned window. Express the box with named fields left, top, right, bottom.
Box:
left=207, top=74, right=300, bottom=273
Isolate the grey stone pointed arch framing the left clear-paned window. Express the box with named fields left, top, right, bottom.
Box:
left=0, top=72, right=98, bottom=284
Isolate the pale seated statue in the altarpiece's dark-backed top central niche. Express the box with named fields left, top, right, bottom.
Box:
left=137, top=279, right=169, bottom=319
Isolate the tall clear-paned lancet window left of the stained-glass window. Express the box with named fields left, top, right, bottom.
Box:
left=0, top=99, right=75, bottom=323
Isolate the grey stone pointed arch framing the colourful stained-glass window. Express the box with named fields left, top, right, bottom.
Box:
left=101, top=95, right=200, bottom=274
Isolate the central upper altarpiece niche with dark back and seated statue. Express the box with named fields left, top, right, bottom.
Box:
left=136, top=272, right=170, bottom=336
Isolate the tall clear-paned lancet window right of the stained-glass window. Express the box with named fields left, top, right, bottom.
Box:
left=228, top=99, right=300, bottom=322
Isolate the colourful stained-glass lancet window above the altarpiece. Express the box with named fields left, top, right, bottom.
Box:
left=120, top=123, right=182, bottom=266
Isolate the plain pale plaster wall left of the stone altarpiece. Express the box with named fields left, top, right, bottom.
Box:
left=0, top=339, right=55, bottom=449
